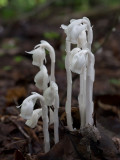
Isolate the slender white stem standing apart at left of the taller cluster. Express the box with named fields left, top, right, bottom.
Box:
left=65, top=40, right=73, bottom=131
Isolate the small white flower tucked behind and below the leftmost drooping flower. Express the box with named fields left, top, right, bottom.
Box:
left=25, top=108, right=42, bottom=128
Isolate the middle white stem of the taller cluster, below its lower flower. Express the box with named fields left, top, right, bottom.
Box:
left=78, top=67, right=86, bottom=128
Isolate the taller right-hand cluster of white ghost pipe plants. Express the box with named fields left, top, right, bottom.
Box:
left=61, top=17, right=95, bottom=131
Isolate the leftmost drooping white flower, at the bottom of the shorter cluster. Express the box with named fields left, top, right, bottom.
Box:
left=17, top=93, right=40, bottom=119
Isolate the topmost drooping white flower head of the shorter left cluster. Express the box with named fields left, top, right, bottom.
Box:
left=26, top=46, right=46, bottom=67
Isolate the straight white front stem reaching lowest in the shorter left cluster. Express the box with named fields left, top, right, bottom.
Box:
left=42, top=102, right=50, bottom=153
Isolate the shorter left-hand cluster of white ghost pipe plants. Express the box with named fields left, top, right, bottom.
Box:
left=18, top=41, right=59, bottom=152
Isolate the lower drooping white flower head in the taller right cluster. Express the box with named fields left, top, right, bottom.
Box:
left=70, top=48, right=87, bottom=74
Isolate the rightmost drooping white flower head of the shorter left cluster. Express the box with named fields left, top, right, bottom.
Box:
left=43, top=81, right=58, bottom=106
